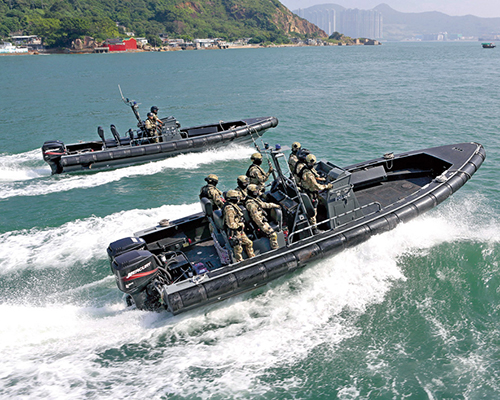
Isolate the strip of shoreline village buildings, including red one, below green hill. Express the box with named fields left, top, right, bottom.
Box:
left=0, top=35, right=381, bottom=54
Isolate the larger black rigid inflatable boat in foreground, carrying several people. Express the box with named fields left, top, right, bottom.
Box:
left=107, top=143, right=485, bottom=314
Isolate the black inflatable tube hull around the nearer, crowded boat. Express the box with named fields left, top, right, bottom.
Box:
left=106, top=143, right=485, bottom=314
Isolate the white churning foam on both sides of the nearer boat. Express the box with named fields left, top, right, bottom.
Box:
left=0, top=194, right=500, bottom=399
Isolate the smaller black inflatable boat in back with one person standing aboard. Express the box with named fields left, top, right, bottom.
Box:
left=42, top=117, right=278, bottom=174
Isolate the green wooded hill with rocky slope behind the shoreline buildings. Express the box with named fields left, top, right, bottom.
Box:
left=0, top=0, right=326, bottom=46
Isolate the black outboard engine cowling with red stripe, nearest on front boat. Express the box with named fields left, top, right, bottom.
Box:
left=111, top=250, right=158, bottom=294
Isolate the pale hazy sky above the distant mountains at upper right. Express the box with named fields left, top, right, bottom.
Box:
left=280, top=0, right=500, bottom=18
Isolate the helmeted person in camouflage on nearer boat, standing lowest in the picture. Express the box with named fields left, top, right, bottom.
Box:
left=224, top=190, right=255, bottom=262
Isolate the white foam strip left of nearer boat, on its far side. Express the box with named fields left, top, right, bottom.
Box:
left=0, top=203, right=201, bottom=275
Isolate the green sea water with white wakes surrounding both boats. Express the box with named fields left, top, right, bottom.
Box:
left=0, top=43, right=500, bottom=399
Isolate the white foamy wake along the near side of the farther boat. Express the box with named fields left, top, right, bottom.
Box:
left=0, top=145, right=252, bottom=199
